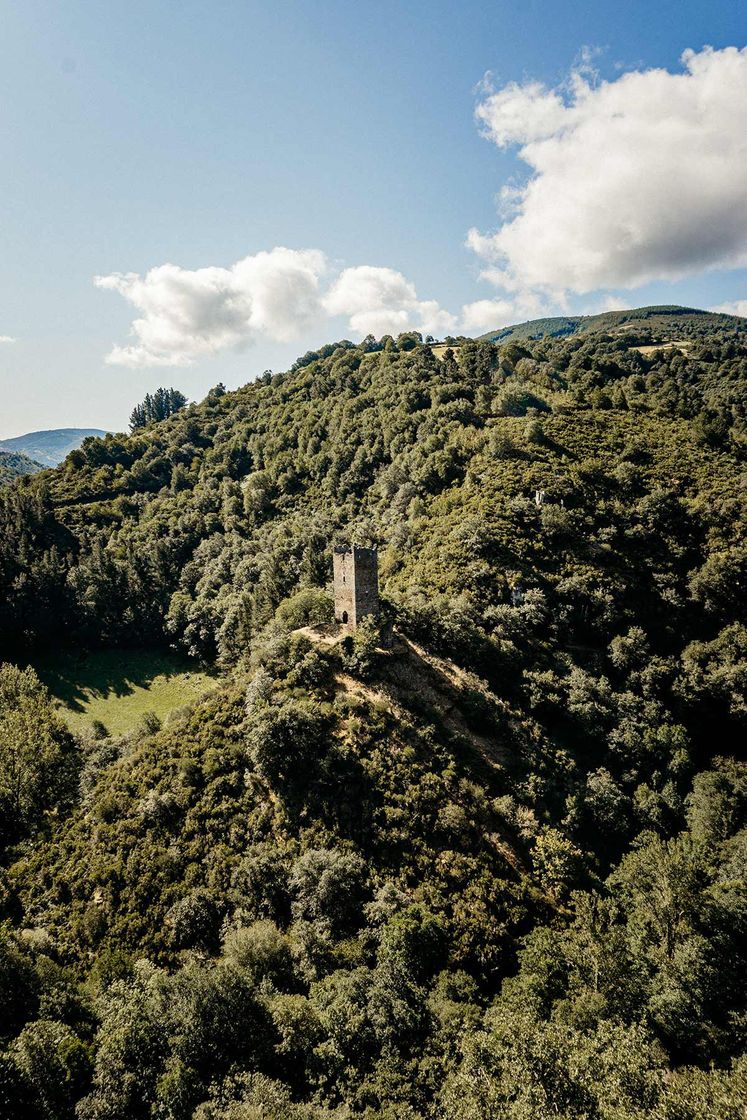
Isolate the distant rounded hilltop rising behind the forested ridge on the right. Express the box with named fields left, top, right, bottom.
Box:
left=480, top=306, right=747, bottom=342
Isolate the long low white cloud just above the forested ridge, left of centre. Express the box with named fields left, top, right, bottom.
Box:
left=94, top=248, right=457, bottom=368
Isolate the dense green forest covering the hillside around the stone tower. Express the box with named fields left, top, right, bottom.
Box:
left=0, top=316, right=747, bottom=1120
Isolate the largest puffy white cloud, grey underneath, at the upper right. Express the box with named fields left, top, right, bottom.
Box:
left=468, top=47, right=747, bottom=293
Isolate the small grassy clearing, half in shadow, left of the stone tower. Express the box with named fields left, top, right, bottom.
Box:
left=34, top=650, right=216, bottom=735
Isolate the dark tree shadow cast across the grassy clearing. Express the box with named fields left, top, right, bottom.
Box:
left=34, top=650, right=214, bottom=712
